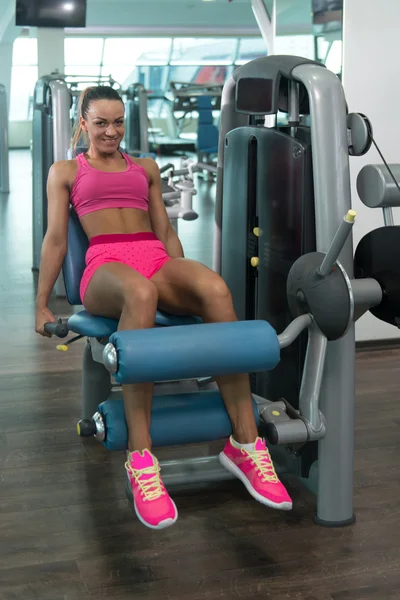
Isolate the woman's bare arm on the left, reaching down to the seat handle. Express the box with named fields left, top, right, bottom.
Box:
left=36, top=161, right=70, bottom=311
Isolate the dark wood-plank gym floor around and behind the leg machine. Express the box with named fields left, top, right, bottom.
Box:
left=0, top=151, right=400, bottom=600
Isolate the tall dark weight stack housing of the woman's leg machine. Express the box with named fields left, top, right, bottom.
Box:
left=221, top=126, right=316, bottom=474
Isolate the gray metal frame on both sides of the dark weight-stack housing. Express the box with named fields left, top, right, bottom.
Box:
left=213, top=59, right=355, bottom=524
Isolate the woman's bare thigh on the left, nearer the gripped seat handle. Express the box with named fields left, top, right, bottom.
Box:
left=84, top=262, right=154, bottom=319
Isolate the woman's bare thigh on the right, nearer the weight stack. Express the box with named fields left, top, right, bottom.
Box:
left=151, top=258, right=230, bottom=315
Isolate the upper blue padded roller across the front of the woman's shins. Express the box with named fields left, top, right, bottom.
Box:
left=110, top=321, right=280, bottom=383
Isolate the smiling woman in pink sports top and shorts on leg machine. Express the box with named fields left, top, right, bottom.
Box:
left=36, top=86, right=292, bottom=529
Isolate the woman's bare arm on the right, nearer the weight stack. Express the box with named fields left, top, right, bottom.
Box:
left=142, top=158, right=184, bottom=258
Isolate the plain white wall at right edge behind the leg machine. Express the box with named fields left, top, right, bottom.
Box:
left=343, top=0, right=400, bottom=340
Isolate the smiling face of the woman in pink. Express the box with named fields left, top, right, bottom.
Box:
left=81, top=100, right=125, bottom=154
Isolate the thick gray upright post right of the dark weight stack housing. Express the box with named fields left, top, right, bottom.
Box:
left=292, top=64, right=355, bottom=527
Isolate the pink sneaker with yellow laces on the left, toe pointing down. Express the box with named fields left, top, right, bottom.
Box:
left=125, top=449, right=178, bottom=529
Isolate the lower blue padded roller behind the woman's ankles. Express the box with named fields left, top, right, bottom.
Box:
left=98, top=391, right=258, bottom=450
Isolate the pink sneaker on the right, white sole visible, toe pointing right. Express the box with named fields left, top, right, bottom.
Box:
left=219, top=436, right=292, bottom=510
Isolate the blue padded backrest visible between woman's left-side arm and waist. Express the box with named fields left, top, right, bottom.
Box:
left=63, top=208, right=89, bottom=304
